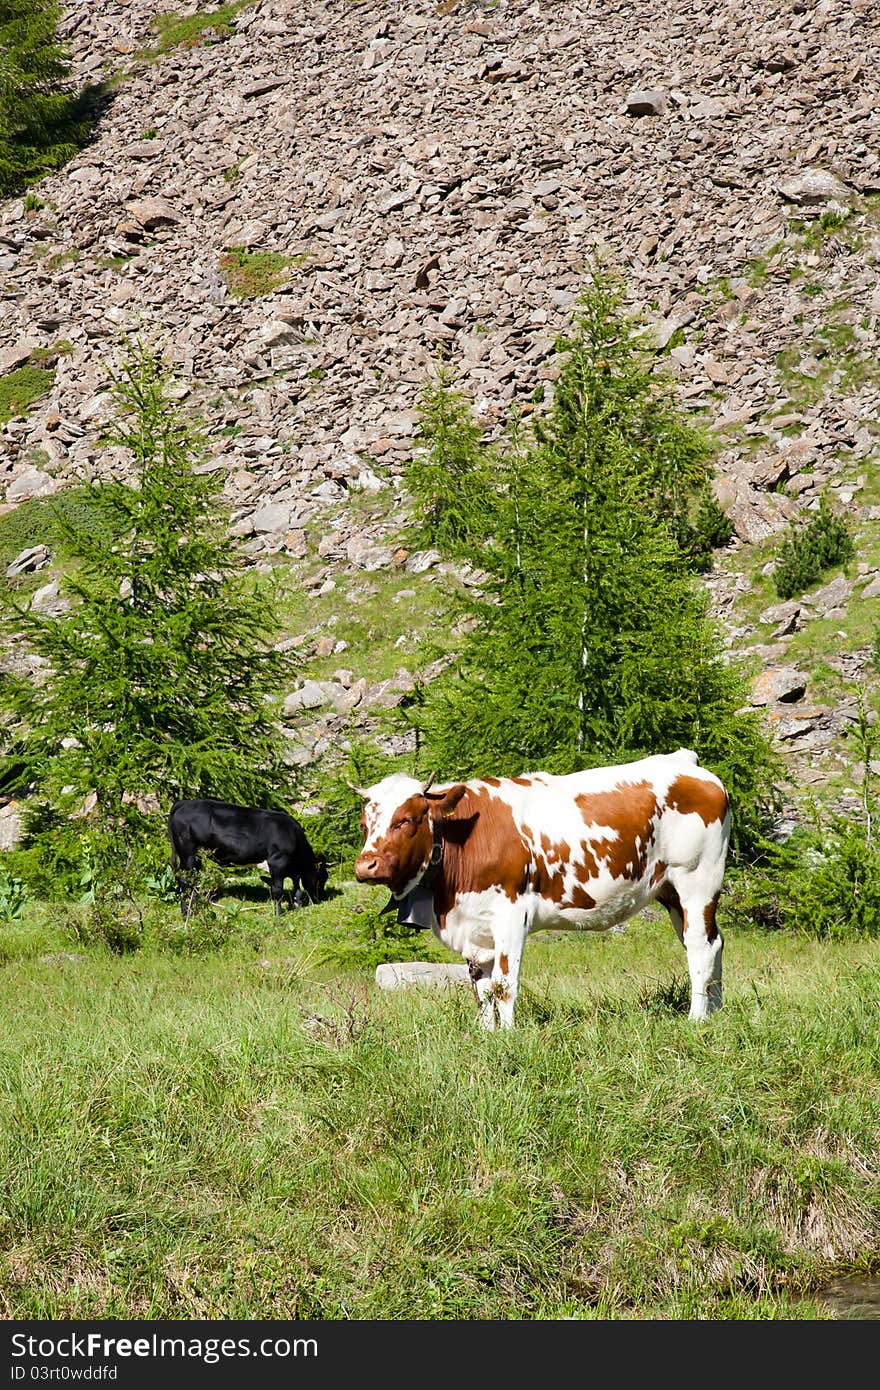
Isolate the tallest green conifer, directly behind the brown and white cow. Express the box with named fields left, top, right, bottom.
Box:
left=410, top=262, right=779, bottom=849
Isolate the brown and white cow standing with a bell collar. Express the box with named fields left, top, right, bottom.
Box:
left=353, top=748, right=730, bottom=1029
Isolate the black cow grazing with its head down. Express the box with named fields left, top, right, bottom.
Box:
left=168, top=798, right=327, bottom=916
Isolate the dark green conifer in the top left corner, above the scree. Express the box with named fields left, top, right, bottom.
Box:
left=0, top=0, right=89, bottom=197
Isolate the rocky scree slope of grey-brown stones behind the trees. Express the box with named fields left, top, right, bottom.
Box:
left=0, top=0, right=880, bottom=811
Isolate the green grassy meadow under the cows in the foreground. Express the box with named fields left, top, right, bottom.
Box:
left=0, top=877, right=880, bottom=1321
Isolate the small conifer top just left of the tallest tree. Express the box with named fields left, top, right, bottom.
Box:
left=405, top=366, right=492, bottom=555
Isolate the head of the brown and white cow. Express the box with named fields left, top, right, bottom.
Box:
left=353, top=773, right=466, bottom=898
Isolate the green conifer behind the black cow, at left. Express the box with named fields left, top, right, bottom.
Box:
left=0, top=345, right=295, bottom=870
